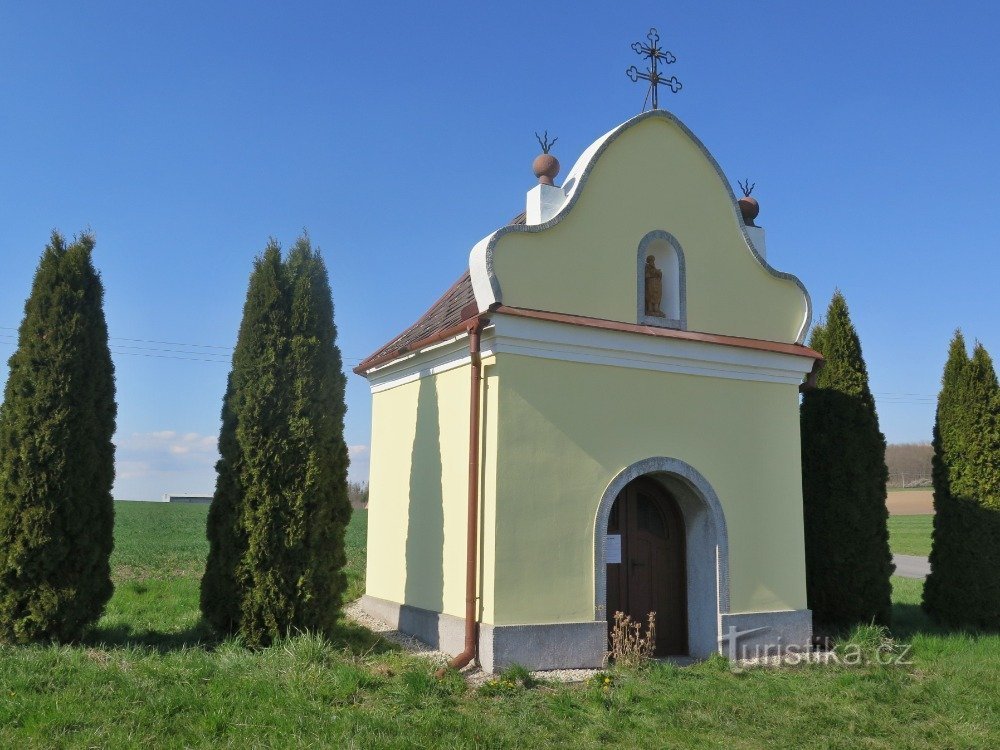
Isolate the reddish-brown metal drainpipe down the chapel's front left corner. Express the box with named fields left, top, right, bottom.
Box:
left=436, top=317, right=486, bottom=677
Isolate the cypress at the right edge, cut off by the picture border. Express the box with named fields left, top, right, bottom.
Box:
left=923, top=332, right=1000, bottom=628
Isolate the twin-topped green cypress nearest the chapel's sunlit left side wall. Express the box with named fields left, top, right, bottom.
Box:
left=201, top=237, right=350, bottom=645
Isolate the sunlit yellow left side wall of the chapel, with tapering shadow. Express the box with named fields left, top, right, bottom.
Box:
left=366, top=359, right=496, bottom=617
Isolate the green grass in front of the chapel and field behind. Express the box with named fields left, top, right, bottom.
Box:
left=0, top=503, right=1000, bottom=748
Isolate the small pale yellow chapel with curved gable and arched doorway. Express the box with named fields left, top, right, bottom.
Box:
left=356, top=110, right=821, bottom=670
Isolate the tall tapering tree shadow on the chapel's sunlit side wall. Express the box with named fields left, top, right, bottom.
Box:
left=400, top=377, right=444, bottom=646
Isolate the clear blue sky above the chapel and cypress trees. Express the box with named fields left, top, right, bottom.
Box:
left=0, top=0, right=1000, bottom=498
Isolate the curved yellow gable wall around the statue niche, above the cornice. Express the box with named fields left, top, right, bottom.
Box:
left=493, top=116, right=808, bottom=342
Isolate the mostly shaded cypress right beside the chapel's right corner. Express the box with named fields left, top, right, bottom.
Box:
left=801, top=291, right=894, bottom=629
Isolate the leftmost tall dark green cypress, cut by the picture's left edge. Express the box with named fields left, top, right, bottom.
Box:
left=0, top=232, right=117, bottom=643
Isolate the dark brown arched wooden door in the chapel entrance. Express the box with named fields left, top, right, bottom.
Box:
left=607, top=477, right=688, bottom=656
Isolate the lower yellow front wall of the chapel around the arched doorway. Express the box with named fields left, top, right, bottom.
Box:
left=491, top=354, right=806, bottom=624
